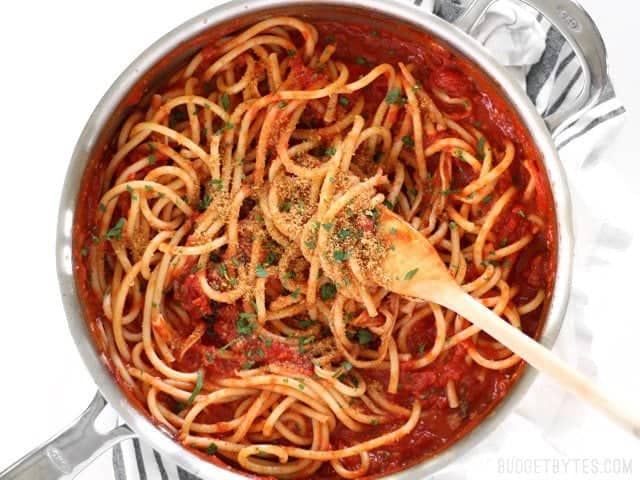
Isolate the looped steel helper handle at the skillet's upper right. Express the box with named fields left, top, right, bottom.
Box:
left=454, top=0, right=611, bottom=140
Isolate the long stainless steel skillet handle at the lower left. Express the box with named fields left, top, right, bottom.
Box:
left=0, top=392, right=135, bottom=480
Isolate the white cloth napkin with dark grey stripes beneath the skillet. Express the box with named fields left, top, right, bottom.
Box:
left=96, top=0, right=640, bottom=480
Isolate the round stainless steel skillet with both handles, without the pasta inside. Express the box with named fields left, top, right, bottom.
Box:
left=0, top=0, right=609, bottom=480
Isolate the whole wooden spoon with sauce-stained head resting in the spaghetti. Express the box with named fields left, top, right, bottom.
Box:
left=373, top=208, right=640, bottom=438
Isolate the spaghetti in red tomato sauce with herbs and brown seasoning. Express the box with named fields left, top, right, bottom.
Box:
left=75, top=17, right=554, bottom=478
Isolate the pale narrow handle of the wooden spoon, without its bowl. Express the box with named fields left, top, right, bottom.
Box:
left=438, top=289, right=640, bottom=439
